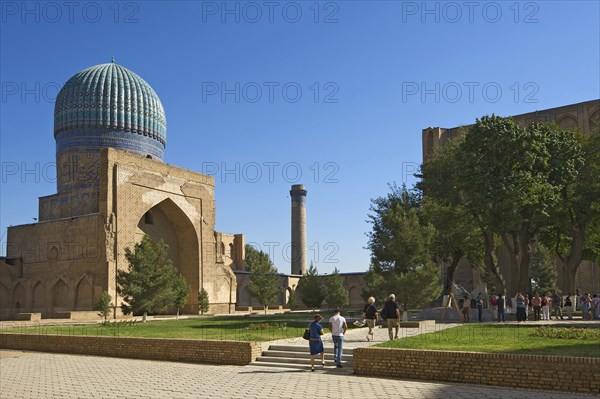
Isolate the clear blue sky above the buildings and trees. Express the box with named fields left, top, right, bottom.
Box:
left=0, top=1, right=600, bottom=273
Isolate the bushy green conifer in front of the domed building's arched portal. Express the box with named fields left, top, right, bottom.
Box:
left=117, top=235, right=182, bottom=321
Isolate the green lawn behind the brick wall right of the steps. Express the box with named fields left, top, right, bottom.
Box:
left=377, top=324, right=600, bottom=357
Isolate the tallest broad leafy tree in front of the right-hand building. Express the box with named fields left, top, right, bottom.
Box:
left=455, top=115, right=577, bottom=293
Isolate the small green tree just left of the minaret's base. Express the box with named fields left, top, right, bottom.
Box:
left=246, top=251, right=281, bottom=314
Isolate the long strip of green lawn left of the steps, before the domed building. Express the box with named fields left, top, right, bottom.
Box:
left=0, top=313, right=353, bottom=341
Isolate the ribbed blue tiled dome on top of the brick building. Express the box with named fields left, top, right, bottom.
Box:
left=54, top=62, right=167, bottom=159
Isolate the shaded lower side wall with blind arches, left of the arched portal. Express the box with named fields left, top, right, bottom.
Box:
left=0, top=214, right=107, bottom=318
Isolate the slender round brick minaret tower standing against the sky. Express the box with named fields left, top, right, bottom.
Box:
left=290, top=184, right=306, bottom=274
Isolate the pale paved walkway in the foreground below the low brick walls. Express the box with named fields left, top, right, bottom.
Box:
left=0, top=350, right=591, bottom=399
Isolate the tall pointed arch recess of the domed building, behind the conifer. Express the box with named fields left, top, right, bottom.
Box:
left=136, top=199, right=200, bottom=313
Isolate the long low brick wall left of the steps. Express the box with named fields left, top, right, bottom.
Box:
left=0, top=334, right=261, bottom=366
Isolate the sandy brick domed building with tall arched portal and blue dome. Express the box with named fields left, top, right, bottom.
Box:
left=0, top=60, right=244, bottom=318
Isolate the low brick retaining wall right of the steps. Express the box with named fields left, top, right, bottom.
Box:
left=353, top=348, right=600, bottom=394
